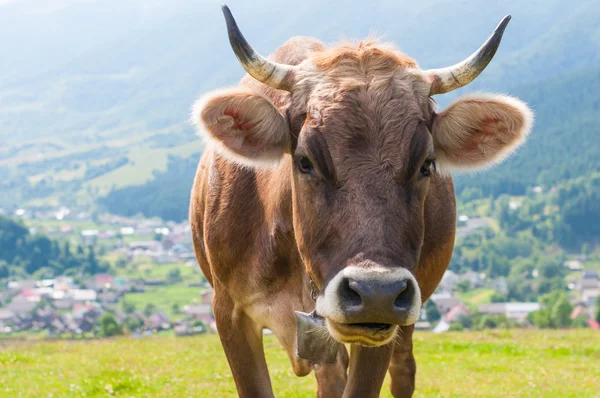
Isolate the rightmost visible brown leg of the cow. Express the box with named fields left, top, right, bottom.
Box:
left=390, top=325, right=417, bottom=398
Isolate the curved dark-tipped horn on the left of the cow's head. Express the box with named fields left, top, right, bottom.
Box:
left=221, top=4, right=295, bottom=91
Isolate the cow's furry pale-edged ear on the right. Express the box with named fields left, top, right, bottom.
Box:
left=432, top=94, right=533, bottom=170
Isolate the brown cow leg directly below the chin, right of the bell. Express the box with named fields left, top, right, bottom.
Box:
left=344, top=343, right=394, bottom=398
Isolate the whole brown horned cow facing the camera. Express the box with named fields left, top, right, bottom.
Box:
left=190, top=6, right=533, bottom=398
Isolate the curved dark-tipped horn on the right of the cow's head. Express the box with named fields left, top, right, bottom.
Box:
left=425, top=15, right=510, bottom=95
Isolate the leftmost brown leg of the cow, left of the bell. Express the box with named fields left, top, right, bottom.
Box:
left=213, top=289, right=273, bottom=398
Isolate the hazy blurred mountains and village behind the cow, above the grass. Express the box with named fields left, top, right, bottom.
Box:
left=0, top=0, right=600, bottom=394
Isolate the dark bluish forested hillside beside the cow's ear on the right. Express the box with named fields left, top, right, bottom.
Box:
left=456, top=68, right=600, bottom=196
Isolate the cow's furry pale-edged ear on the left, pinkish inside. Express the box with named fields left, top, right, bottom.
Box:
left=192, top=87, right=291, bottom=167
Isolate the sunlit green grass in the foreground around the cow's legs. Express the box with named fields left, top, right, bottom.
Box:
left=0, top=330, right=600, bottom=398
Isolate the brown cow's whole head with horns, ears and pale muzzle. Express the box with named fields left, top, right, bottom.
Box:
left=193, top=7, right=533, bottom=346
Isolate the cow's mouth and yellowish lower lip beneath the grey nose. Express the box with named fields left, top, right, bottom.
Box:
left=327, top=319, right=397, bottom=347
